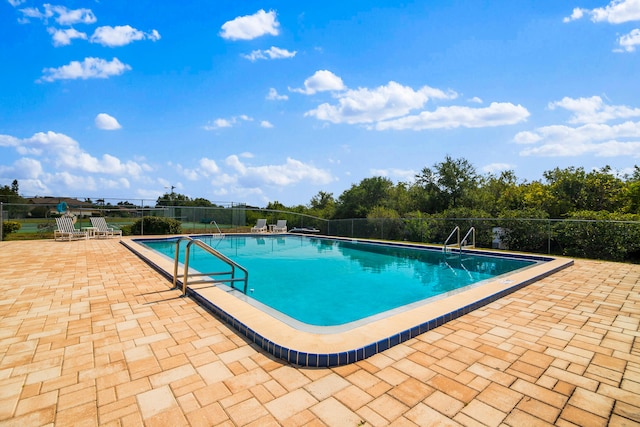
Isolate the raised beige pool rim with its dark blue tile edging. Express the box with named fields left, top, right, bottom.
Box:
left=121, top=234, right=573, bottom=367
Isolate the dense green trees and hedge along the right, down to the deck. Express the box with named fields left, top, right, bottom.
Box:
left=267, top=156, right=640, bottom=262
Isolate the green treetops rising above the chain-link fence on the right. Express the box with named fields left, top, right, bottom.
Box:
left=274, top=156, right=640, bottom=219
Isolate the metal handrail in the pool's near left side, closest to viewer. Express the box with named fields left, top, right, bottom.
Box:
left=173, top=236, right=249, bottom=296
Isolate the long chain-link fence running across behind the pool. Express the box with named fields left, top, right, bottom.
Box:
left=0, top=202, right=640, bottom=262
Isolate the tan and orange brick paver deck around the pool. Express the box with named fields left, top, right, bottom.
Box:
left=0, top=239, right=640, bottom=427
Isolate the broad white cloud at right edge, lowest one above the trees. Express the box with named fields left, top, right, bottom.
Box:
left=514, top=121, right=640, bottom=157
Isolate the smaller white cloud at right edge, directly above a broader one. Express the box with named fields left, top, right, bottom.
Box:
left=549, top=96, right=640, bottom=123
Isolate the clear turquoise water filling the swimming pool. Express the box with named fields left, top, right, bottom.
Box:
left=141, top=235, right=535, bottom=326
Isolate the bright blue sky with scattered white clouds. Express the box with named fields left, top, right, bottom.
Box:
left=0, top=0, right=640, bottom=206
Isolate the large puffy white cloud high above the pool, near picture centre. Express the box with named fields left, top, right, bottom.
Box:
left=305, top=81, right=457, bottom=124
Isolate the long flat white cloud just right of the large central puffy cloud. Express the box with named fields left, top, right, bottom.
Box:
left=373, top=102, right=530, bottom=130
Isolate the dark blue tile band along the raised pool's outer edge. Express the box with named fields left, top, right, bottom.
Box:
left=120, top=240, right=573, bottom=368
